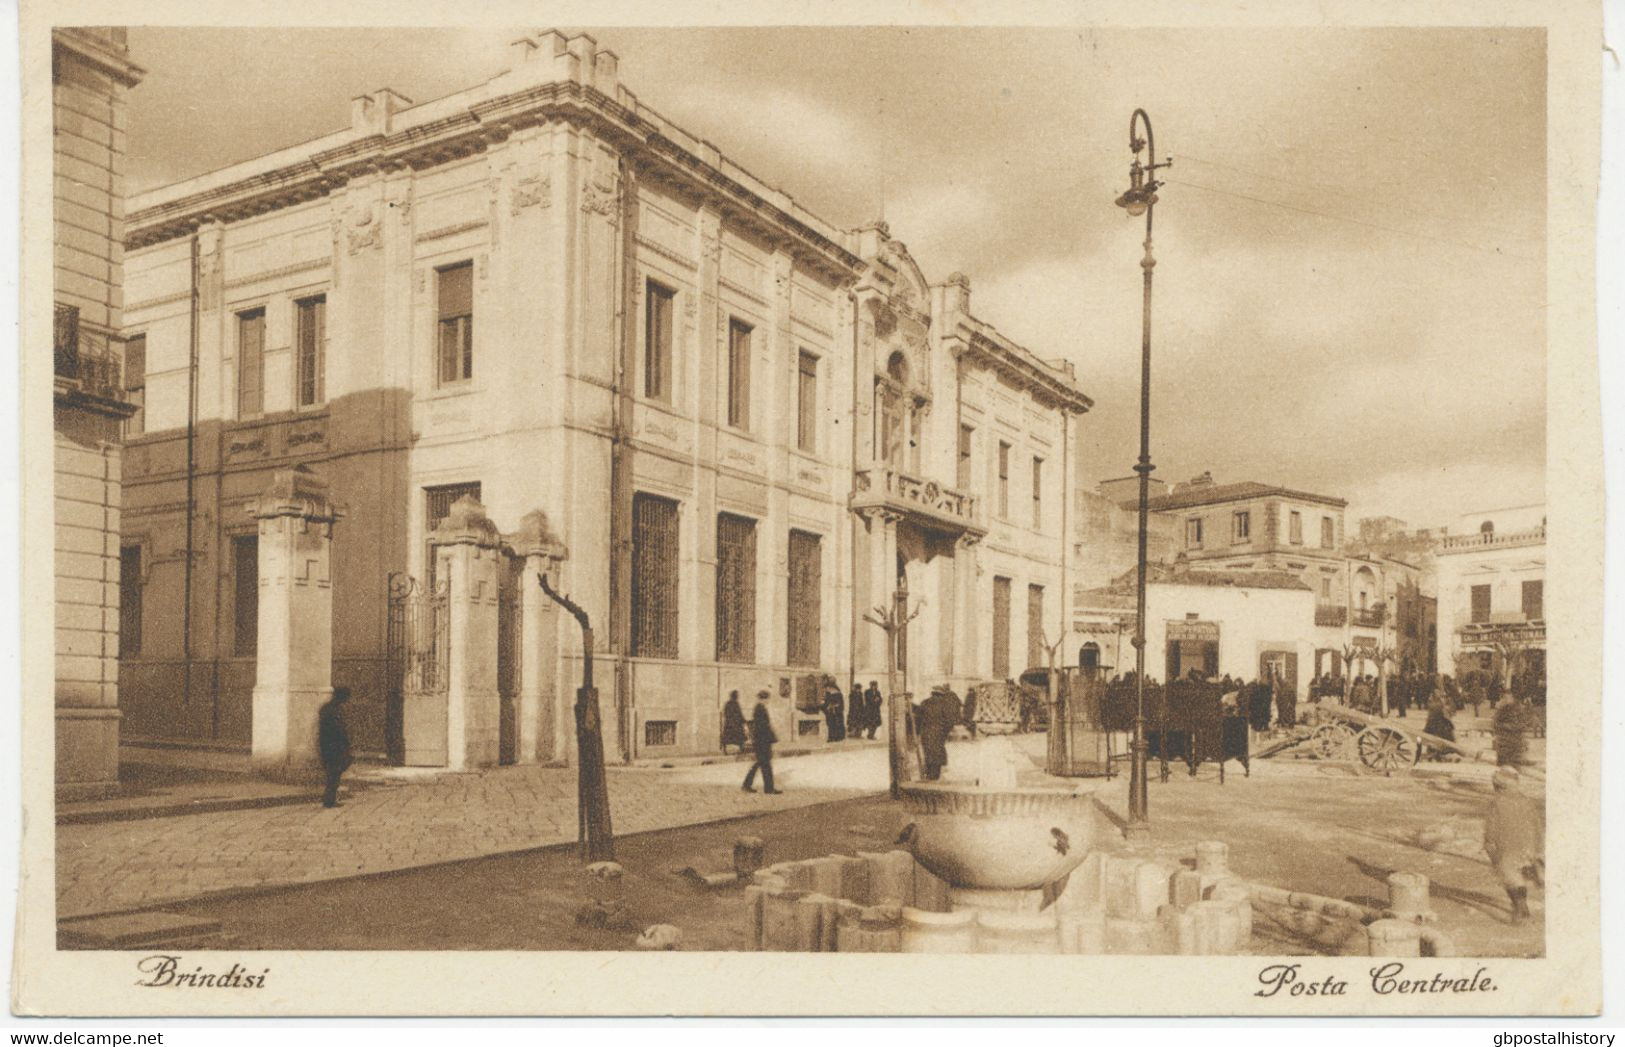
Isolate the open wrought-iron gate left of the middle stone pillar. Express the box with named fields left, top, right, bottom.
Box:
left=384, top=572, right=452, bottom=766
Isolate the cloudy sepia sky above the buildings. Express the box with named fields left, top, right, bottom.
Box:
left=128, top=28, right=1545, bottom=525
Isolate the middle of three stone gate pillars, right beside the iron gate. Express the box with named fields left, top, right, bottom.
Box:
left=432, top=494, right=502, bottom=771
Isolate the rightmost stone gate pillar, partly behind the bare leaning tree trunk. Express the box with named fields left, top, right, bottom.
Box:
left=509, top=509, right=566, bottom=764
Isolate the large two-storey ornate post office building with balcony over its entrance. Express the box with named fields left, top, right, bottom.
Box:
left=122, top=33, right=1089, bottom=759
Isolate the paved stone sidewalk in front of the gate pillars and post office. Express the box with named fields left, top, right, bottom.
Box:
left=57, top=759, right=860, bottom=917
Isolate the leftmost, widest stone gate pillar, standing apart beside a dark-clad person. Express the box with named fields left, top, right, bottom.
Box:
left=249, top=465, right=343, bottom=779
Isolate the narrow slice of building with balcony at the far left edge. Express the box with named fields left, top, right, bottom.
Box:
left=50, top=28, right=145, bottom=798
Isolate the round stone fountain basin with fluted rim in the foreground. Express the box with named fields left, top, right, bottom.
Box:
left=902, top=782, right=1100, bottom=891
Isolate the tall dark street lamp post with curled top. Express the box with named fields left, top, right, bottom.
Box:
left=1116, top=109, right=1173, bottom=839
